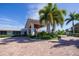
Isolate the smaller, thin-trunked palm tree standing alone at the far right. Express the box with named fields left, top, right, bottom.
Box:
left=65, top=12, right=79, bottom=34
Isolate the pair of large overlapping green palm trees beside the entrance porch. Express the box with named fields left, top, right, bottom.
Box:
left=39, top=3, right=66, bottom=32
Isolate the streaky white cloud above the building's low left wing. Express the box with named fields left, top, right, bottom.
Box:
left=0, top=18, right=23, bottom=30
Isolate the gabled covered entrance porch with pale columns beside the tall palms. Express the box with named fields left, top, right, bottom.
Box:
left=24, top=19, right=41, bottom=35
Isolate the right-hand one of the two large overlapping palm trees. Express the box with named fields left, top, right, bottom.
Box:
left=52, top=4, right=66, bottom=31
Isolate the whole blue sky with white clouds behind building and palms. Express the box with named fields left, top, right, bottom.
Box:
left=0, top=3, right=79, bottom=29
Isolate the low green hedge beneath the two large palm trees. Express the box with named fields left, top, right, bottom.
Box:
left=30, top=30, right=65, bottom=39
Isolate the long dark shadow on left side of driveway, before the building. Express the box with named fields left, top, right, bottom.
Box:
left=1, top=37, right=45, bottom=44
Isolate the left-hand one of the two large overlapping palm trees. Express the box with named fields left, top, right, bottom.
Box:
left=39, top=3, right=53, bottom=32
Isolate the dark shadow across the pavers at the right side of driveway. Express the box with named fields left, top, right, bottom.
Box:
left=51, top=39, right=79, bottom=48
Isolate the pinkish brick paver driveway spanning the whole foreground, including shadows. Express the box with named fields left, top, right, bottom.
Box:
left=0, top=37, right=79, bottom=56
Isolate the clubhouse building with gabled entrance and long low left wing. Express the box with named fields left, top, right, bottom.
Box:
left=0, top=18, right=50, bottom=35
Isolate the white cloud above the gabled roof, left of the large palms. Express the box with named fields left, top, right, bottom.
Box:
left=25, top=3, right=46, bottom=19
